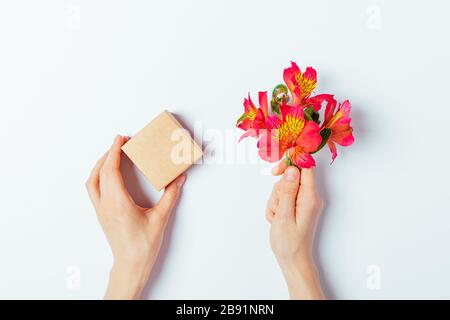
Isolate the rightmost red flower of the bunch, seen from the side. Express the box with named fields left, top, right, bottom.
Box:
left=322, top=99, right=355, bottom=162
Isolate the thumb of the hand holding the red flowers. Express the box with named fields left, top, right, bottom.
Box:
left=276, top=167, right=300, bottom=220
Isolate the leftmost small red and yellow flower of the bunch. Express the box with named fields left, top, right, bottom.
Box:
left=236, top=92, right=269, bottom=141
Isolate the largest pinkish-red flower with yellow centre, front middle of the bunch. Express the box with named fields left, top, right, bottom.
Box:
left=258, top=105, right=322, bottom=168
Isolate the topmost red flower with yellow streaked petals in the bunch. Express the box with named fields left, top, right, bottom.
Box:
left=283, top=61, right=317, bottom=107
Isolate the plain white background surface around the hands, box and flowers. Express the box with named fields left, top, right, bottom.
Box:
left=0, top=0, right=450, bottom=299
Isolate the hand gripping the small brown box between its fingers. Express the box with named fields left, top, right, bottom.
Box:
left=86, top=136, right=186, bottom=299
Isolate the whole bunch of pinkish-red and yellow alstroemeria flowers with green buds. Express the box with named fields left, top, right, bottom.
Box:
left=237, top=62, right=354, bottom=168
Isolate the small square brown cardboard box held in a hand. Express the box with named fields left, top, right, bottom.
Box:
left=122, top=111, right=202, bottom=191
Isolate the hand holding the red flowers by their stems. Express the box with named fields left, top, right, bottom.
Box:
left=266, top=163, right=324, bottom=299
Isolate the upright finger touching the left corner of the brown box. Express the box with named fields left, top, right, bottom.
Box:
left=100, top=135, right=130, bottom=198
